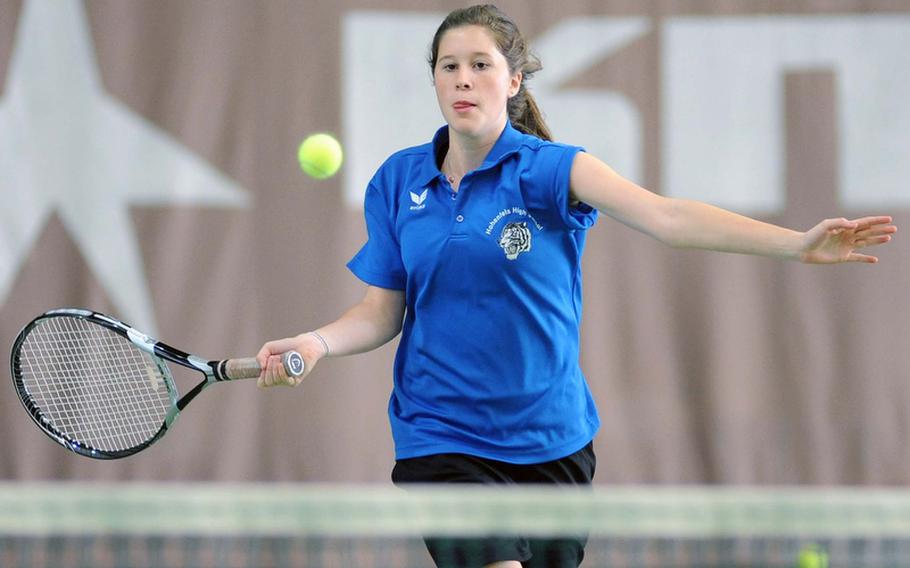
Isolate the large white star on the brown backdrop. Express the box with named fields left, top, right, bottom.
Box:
left=0, top=0, right=250, bottom=332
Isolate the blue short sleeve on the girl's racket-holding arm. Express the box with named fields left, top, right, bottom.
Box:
left=347, top=184, right=407, bottom=290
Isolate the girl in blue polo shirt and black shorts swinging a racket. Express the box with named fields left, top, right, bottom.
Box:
left=257, top=6, right=896, bottom=568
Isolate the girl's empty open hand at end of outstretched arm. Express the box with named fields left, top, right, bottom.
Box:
left=799, top=216, right=897, bottom=264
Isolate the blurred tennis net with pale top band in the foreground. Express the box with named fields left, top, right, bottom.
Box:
left=0, top=483, right=910, bottom=568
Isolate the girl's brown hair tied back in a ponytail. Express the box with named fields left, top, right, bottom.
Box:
left=427, top=4, right=553, bottom=140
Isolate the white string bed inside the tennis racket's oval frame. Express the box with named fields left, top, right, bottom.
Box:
left=20, top=317, right=171, bottom=451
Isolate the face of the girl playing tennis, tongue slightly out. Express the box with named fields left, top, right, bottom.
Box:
left=433, top=26, right=521, bottom=140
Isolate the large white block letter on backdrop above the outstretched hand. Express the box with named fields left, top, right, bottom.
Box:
left=661, top=15, right=910, bottom=213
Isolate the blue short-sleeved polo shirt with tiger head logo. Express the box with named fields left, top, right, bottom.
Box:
left=348, top=124, right=600, bottom=464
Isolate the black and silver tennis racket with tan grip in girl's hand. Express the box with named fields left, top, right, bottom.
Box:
left=10, top=308, right=305, bottom=459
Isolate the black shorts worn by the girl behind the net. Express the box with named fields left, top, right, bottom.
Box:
left=392, top=444, right=597, bottom=568
